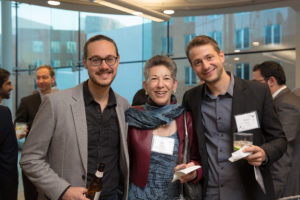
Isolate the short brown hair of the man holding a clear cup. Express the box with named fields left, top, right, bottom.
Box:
left=185, top=35, right=221, bottom=62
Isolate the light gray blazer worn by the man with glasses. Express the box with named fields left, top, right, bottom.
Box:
left=20, top=84, right=130, bottom=200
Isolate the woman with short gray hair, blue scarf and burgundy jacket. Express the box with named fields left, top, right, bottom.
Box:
left=125, top=55, right=202, bottom=200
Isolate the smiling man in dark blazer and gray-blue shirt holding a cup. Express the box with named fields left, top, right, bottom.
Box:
left=183, top=35, right=287, bottom=200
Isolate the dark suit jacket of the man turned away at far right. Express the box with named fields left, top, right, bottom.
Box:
left=271, top=88, right=300, bottom=199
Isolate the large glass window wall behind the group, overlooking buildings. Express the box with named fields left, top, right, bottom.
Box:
left=12, top=3, right=296, bottom=114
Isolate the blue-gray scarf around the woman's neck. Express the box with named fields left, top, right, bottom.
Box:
left=125, top=95, right=184, bottom=129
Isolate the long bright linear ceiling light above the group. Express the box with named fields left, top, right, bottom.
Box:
left=90, top=0, right=170, bottom=22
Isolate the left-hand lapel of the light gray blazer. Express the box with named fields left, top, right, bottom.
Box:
left=71, top=84, right=88, bottom=172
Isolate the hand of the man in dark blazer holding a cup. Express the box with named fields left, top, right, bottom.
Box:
left=243, top=145, right=266, bottom=167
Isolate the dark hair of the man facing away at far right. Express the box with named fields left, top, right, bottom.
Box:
left=253, top=61, right=286, bottom=85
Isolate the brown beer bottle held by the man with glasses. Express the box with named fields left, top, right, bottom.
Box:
left=86, top=163, right=105, bottom=200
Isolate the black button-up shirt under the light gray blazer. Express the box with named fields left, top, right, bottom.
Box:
left=83, top=81, right=121, bottom=199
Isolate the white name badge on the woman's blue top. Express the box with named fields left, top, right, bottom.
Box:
left=151, top=135, right=175, bottom=155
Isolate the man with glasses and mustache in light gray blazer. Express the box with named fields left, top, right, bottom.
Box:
left=20, top=35, right=129, bottom=200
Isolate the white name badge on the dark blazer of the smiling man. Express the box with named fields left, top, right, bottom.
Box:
left=234, top=111, right=259, bottom=132
